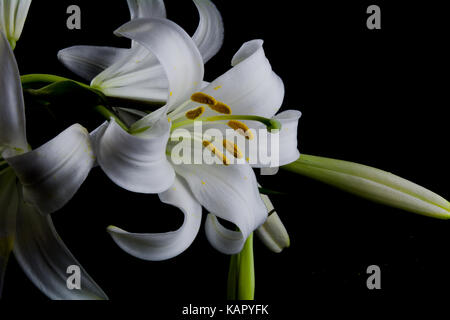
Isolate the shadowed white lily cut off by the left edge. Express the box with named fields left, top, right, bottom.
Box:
left=0, top=34, right=107, bottom=299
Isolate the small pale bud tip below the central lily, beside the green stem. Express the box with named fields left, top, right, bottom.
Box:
left=256, top=195, right=291, bottom=253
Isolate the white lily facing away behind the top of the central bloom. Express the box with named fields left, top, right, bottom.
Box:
left=58, top=0, right=223, bottom=103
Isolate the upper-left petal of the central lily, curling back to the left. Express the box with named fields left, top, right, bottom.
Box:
left=110, top=19, right=204, bottom=129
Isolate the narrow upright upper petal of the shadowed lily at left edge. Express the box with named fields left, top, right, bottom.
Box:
left=0, top=31, right=28, bottom=152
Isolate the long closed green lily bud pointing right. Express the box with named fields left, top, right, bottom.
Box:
left=282, top=154, right=450, bottom=219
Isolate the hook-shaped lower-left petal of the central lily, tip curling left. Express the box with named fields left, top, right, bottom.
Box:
left=108, top=177, right=202, bottom=261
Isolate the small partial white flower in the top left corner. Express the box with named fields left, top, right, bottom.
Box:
left=0, top=0, right=31, bottom=50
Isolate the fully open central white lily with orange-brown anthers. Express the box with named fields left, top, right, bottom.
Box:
left=90, top=19, right=300, bottom=260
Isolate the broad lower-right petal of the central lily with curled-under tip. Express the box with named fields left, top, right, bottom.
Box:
left=174, top=164, right=267, bottom=254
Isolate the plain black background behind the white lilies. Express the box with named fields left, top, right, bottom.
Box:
left=0, top=0, right=450, bottom=314
